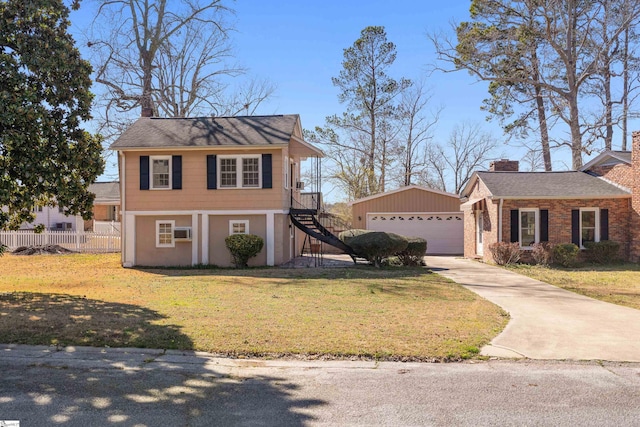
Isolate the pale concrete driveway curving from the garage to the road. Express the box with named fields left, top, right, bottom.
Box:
left=426, top=256, right=640, bottom=362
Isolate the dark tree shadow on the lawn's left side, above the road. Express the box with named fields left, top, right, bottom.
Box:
left=0, top=292, right=193, bottom=349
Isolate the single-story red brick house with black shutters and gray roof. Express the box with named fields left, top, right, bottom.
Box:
left=461, top=132, right=640, bottom=262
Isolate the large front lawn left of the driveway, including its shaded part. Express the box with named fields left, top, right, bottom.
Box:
left=0, top=255, right=508, bottom=360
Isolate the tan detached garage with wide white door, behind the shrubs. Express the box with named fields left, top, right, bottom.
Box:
left=350, top=185, right=464, bottom=255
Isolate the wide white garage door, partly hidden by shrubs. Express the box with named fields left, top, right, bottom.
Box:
left=366, top=212, right=464, bottom=255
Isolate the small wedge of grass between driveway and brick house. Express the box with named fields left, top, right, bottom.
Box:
left=509, top=264, right=640, bottom=310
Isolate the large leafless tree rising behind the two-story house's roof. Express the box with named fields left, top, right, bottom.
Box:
left=88, top=0, right=275, bottom=139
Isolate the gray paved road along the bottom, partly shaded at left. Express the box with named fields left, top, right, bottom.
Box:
left=0, top=345, right=640, bottom=427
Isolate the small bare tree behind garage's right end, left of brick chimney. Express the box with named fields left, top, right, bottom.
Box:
left=427, top=122, right=497, bottom=194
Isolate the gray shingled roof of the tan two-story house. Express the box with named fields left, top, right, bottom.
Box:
left=110, top=114, right=298, bottom=150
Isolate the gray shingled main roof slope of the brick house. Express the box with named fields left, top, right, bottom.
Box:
left=477, top=171, right=630, bottom=199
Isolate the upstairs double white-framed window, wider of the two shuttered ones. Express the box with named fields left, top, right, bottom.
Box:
left=218, top=155, right=262, bottom=188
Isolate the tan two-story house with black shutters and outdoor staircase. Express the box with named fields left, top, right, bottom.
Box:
left=110, top=115, right=323, bottom=267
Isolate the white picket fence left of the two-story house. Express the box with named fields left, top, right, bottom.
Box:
left=0, top=230, right=121, bottom=253
